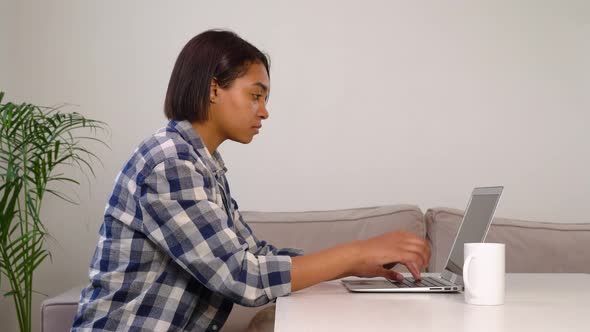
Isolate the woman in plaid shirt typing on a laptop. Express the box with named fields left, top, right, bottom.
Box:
left=73, top=30, right=430, bottom=331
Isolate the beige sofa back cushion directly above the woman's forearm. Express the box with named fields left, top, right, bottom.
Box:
left=242, top=205, right=426, bottom=271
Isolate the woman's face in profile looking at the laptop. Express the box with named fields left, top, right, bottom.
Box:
left=209, top=63, right=270, bottom=144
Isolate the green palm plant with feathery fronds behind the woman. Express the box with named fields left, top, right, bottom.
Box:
left=0, top=91, right=108, bottom=331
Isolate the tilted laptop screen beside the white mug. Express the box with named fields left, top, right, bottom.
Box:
left=446, top=188, right=501, bottom=276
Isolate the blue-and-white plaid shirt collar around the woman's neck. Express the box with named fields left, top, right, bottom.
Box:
left=168, top=120, right=227, bottom=175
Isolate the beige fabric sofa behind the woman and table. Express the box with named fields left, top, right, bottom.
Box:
left=41, top=205, right=590, bottom=332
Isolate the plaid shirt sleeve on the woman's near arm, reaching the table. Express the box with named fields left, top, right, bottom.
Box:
left=140, top=159, right=291, bottom=306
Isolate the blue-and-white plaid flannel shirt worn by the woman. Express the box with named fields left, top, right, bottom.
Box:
left=72, top=121, right=302, bottom=331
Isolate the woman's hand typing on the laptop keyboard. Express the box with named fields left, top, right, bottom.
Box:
left=350, top=231, right=430, bottom=280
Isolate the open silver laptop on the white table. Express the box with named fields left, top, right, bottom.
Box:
left=342, top=187, right=504, bottom=293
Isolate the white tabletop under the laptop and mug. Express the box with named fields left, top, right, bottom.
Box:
left=275, top=274, right=590, bottom=332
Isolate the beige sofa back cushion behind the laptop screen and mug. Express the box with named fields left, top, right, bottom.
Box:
left=425, top=208, right=590, bottom=273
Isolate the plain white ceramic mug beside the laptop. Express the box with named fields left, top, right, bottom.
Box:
left=463, top=243, right=506, bottom=305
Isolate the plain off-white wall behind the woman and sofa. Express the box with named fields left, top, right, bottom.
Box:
left=0, top=0, right=590, bottom=330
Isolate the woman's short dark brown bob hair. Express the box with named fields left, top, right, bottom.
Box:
left=164, top=29, right=270, bottom=123
